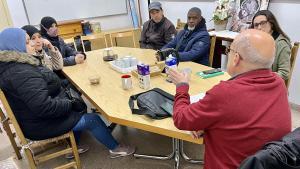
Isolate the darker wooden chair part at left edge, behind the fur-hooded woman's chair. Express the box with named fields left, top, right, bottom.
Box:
left=0, top=103, right=22, bottom=160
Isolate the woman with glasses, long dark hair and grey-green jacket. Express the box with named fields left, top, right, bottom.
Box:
left=251, top=10, right=292, bottom=80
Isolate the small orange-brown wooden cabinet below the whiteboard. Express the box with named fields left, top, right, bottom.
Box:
left=57, top=20, right=82, bottom=39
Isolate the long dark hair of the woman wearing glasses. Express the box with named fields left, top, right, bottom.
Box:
left=250, top=10, right=290, bottom=41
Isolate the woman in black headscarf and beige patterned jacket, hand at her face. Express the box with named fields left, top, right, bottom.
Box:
left=22, top=25, right=63, bottom=70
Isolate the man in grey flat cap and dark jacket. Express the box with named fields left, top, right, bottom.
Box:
left=140, top=2, right=176, bottom=50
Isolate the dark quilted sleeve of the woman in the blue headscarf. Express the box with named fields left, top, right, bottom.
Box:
left=11, top=67, right=72, bottom=118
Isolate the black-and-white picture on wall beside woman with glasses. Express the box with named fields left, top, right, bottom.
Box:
left=230, top=0, right=270, bottom=32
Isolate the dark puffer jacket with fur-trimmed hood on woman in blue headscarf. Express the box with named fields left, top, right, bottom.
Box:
left=0, top=51, right=82, bottom=140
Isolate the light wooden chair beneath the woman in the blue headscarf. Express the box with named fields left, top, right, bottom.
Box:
left=0, top=89, right=81, bottom=169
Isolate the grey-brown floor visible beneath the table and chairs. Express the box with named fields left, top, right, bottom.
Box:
left=0, top=107, right=300, bottom=169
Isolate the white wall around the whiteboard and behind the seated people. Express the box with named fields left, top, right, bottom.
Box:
left=7, top=0, right=300, bottom=105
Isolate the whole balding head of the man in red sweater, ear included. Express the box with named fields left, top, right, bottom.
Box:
left=227, top=29, right=275, bottom=76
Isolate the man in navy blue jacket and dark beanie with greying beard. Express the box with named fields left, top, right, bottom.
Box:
left=162, top=7, right=210, bottom=65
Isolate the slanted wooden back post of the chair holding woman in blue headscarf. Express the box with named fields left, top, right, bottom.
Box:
left=0, top=89, right=28, bottom=145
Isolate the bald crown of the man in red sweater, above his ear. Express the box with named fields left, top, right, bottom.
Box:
left=232, top=29, right=275, bottom=68
